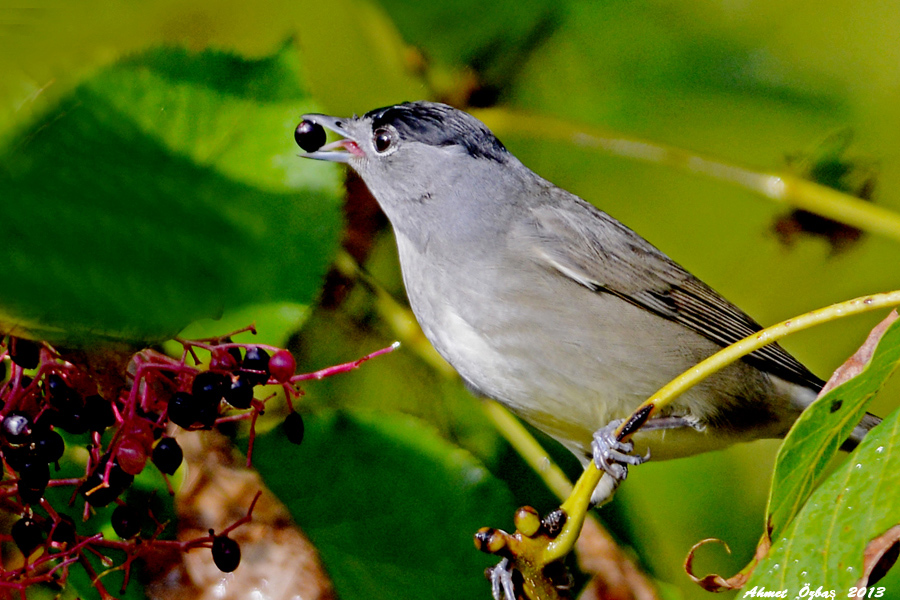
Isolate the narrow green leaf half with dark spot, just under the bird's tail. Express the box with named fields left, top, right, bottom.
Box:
left=767, top=319, right=900, bottom=539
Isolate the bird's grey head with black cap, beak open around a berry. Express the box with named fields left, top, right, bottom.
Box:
left=295, top=102, right=521, bottom=227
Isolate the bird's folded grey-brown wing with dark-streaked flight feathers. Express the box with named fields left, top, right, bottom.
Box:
left=516, top=199, right=823, bottom=390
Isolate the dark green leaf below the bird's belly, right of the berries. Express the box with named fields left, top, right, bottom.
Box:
left=253, top=413, right=514, bottom=600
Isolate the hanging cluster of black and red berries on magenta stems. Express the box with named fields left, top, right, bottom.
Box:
left=0, top=328, right=393, bottom=598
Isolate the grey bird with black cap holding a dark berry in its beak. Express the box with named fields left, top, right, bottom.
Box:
left=295, top=101, right=879, bottom=482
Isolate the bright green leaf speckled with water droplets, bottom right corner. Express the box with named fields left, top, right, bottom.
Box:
left=745, top=404, right=900, bottom=598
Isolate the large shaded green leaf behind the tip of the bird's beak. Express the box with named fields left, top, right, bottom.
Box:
left=0, top=45, right=341, bottom=343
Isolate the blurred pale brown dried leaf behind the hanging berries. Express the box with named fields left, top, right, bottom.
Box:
left=148, top=431, right=337, bottom=600
